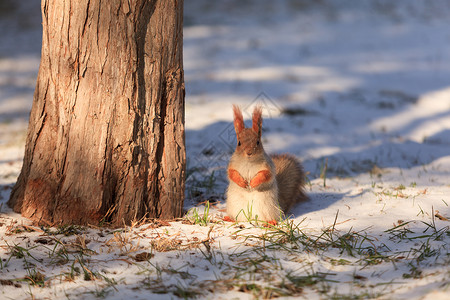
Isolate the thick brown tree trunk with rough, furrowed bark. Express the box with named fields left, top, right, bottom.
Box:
left=8, top=0, right=185, bottom=225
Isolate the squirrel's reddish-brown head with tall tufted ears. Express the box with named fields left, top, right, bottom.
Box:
left=233, top=105, right=264, bottom=158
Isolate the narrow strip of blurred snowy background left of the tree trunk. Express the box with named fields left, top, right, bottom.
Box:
left=0, top=0, right=42, bottom=192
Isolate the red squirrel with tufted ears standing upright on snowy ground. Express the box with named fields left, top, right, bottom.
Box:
left=226, top=105, right=308, bottom=223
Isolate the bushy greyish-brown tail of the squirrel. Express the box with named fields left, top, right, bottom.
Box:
left=271, top=154, right=308, bottom=214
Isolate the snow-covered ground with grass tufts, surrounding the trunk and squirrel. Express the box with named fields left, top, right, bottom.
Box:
left=0, top=0, right=450, bottom=299
